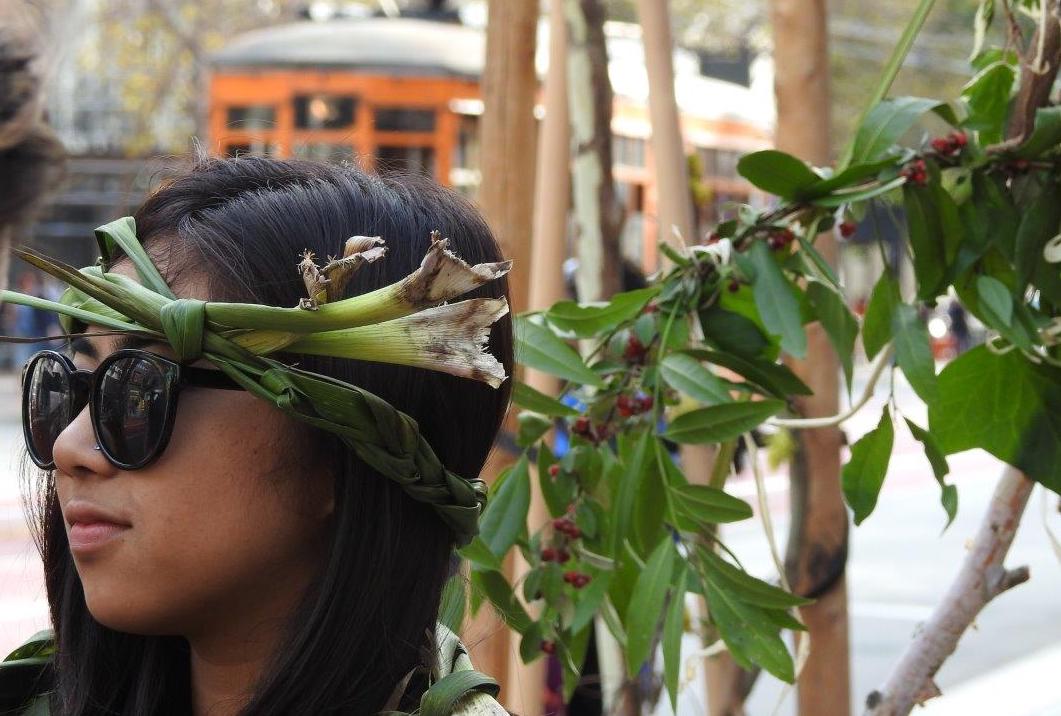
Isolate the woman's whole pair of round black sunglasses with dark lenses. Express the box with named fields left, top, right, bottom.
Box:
left=22, top=348, right=243, bottom=470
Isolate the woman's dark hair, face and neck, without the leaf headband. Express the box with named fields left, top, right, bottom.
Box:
left=0, top=157, right=512, bottom=716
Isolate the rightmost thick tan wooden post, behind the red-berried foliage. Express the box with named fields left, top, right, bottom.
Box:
left=771, top=0, right=851, bottom=716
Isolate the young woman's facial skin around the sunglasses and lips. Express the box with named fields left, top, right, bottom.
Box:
left=46, top=262, right=333, bottom=638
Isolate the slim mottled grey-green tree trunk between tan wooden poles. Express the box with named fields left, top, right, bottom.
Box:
left=564, top=0, right=623, bottom=301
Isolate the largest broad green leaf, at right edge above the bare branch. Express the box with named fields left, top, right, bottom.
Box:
left=928, top=346, right=1061, bottom=493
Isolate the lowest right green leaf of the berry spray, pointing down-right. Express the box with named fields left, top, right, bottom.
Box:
left=703, top=574, right=796, bottom=683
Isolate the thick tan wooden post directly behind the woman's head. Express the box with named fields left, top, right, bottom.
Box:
left=465, top=0, right=544, bottom=714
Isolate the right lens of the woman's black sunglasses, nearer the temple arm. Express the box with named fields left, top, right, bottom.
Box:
left=94, top=356, right=170, bottom=467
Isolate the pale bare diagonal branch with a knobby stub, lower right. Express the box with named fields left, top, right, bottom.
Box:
left=865, top=466, right=1034, bottom=716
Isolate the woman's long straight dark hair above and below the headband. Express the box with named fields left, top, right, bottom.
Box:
left=23, top=157, right=512, bottom=716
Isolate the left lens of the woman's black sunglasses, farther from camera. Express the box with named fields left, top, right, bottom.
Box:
left=22, top=354, right=74, bottom=466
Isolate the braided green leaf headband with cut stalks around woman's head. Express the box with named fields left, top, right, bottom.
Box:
left=0, top=216, right=511, bottom=545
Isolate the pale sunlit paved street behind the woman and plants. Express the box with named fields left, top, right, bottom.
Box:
left=0, top=367, right=1061, bottom=716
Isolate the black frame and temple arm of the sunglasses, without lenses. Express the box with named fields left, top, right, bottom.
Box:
left=20, top=348, right=245, bottom=470
